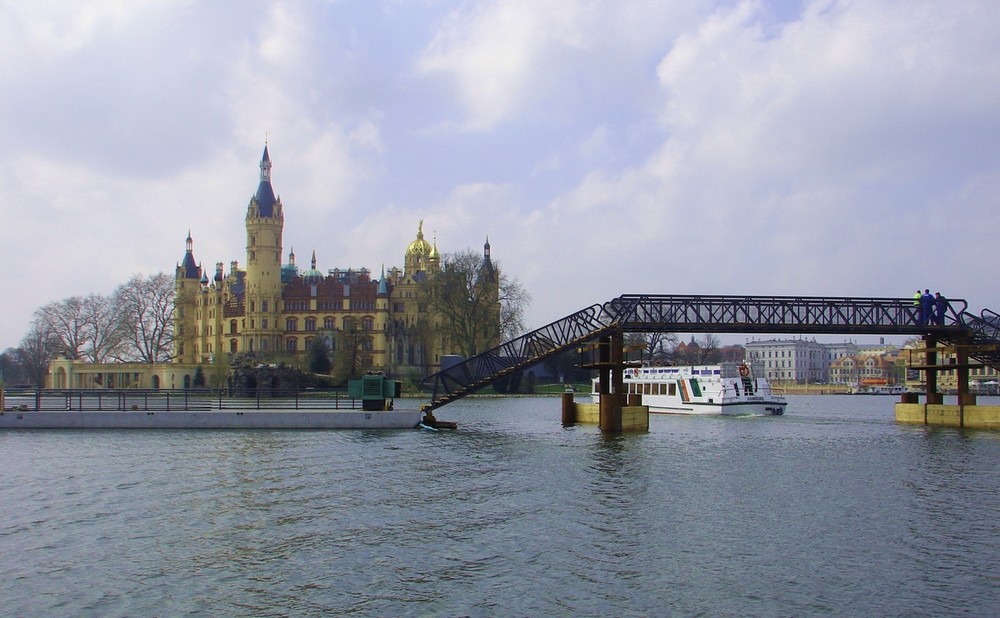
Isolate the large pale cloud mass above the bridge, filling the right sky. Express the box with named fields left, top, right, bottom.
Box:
left=508, top=2, right=1000, bottom=322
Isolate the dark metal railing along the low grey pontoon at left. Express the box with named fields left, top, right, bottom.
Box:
left=3, top=388, right=361, bottom=412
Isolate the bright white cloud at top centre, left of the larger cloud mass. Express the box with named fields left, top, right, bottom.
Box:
left=416, top=0, right=699, bottom=132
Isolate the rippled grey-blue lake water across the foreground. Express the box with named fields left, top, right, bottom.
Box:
left=0, top=396, right=1000, bottom=617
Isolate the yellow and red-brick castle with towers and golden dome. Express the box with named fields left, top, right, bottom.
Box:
left=173, top=145, right=499, bottom=376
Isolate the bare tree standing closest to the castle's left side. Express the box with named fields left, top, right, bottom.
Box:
left=113, top=273, right=175, bottom=363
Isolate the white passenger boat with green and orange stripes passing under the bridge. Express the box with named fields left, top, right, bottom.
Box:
left=591, top=363, right=787, bottom=415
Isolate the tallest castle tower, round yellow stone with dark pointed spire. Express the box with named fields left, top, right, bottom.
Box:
left=241, top=144, right=285, bottom=355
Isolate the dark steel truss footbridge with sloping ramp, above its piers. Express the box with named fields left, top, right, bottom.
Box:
left=423, top=294, right=1000, bottom=410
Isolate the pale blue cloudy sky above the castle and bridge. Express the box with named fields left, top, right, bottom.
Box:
left=0, top=0, right=1000, bottom=350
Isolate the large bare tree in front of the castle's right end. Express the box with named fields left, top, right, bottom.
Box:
left=424, top=250, right=531, bottom=358
